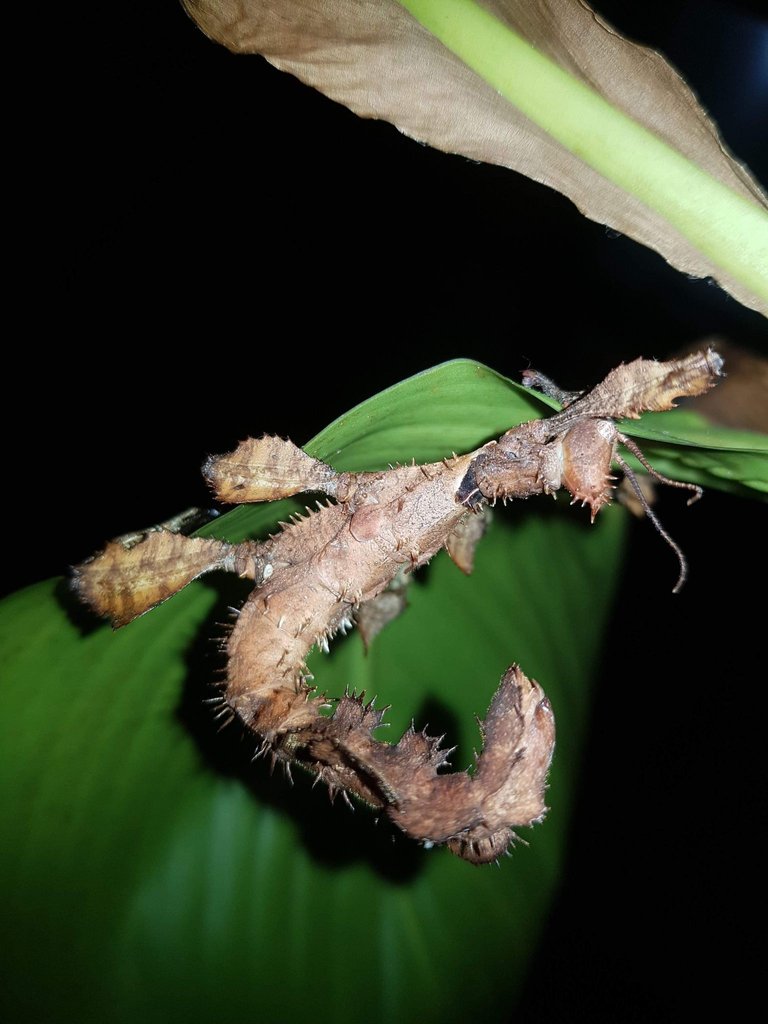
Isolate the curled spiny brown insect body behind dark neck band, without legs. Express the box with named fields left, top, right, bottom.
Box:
left=204, top=439, right=554, bottom=863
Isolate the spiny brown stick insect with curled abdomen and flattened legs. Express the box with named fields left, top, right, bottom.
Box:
left=72, top=350, right=722, bottom=864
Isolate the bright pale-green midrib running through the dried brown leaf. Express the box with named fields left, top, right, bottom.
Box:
left=398, top=0, right=768, bottom=301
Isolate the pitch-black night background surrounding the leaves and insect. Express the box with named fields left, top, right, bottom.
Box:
left=3, top=0, right=768, bottom=1022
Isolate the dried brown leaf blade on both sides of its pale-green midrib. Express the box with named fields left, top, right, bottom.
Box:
left=182, top=0, right=768, bottom=312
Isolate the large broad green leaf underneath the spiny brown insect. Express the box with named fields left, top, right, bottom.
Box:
left=0, top=360, right=753, bottom=1024
